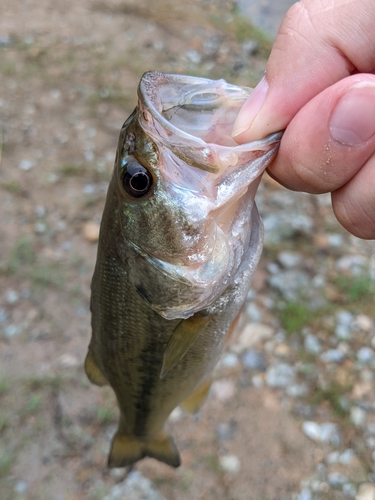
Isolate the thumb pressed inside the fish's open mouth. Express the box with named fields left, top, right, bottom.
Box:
left=232, top=0, right=375, bottom=143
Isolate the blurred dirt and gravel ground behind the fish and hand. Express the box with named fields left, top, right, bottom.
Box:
left=0, top=0, right=375, bottom=500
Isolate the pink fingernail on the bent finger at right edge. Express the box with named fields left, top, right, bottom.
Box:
left=330, top=82, right=375, bottom=146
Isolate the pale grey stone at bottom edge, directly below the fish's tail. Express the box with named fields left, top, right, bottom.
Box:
left=103, top=471, right=166, bottom=500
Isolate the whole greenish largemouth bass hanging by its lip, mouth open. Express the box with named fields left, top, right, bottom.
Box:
left=85, top=71, right=281, bottom=467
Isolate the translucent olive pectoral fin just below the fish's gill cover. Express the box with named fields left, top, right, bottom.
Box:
left=160, top=313, right=212, bottom=378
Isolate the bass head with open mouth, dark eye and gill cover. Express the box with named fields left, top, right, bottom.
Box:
left=112, top=72, right=281, bottom=319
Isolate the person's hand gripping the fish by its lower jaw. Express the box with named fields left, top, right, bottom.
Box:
left=233, top=0, right=375, bottom=239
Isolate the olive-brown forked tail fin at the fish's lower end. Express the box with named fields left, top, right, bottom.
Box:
left=108, top=432, right=181, bottom=467
